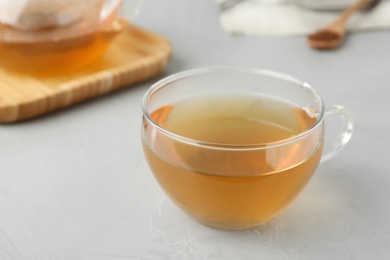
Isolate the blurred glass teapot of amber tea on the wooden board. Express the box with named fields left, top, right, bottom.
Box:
left=0, top=0, right=141, bottom=75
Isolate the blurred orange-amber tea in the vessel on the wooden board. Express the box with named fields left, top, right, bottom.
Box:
left=0, top=22, right=121, bottom=76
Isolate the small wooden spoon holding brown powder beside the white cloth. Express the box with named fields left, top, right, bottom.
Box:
left=307, top=0, right=374, bottom=50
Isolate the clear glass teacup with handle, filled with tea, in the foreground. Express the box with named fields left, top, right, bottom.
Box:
left=142, top=67, right=353, bottom=229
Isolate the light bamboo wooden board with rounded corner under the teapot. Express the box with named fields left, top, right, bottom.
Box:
left=0, top=27, right=172, bottom=123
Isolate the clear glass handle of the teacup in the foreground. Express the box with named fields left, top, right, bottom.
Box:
left=321, top=105, right=353, bottom=162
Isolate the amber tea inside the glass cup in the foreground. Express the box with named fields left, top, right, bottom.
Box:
left=143, top=96, right=322, bottom=229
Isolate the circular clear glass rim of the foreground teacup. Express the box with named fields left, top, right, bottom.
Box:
left=141, top=66, right=325, bottom=151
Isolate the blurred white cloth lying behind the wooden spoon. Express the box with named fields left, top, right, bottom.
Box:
left=216, top=0, right=390, bottom=36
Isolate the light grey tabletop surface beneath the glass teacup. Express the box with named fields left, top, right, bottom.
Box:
left=0, top=0, right=390, bottom=260
